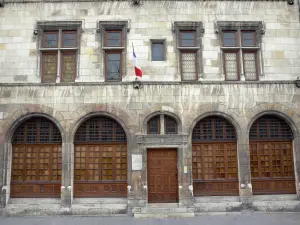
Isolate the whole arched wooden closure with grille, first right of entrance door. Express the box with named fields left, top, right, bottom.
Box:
left=192, top=116, right=239, bottom=196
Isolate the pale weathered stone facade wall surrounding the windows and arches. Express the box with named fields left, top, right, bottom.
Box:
left=0, top=0, right=300, bottom=214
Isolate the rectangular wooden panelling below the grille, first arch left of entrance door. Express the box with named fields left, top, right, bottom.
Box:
left=74, top=144, right=127, bottom=197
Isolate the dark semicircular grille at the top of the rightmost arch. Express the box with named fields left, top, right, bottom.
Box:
left=250, top=116, right=293, bottom=140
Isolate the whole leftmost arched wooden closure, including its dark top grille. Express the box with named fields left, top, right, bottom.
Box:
left=11, top=117, right=62, bottom=198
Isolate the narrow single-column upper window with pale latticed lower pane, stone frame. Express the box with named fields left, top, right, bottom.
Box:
left=174, top=22, right=203, bottom=81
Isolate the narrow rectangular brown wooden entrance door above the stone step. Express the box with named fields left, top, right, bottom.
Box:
left=147, top=149, right=178, bottom=203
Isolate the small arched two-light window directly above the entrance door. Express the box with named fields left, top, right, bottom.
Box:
left=147, top=114, right=178, bottom=134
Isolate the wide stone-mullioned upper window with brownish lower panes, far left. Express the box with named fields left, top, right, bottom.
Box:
left=38, top=21, right=81, bottom=83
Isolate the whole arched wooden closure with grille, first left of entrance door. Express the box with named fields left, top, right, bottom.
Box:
left=74, top=116, right=127, bottom=197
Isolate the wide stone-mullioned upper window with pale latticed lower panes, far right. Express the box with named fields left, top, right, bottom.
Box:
left=218, top=22, right=262, bottom=81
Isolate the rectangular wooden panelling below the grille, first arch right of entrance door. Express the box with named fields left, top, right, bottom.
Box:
left=192, top=142, right=239, bottom=196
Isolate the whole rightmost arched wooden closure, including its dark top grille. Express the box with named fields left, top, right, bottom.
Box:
left=249, top=116, right=296, bottom=194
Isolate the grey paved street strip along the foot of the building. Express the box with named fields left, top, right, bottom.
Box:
left=0, top=213, right=300, bottom=225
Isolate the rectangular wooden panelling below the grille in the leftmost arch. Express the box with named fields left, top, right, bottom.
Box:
left=11, top=144, right=62, bottom=198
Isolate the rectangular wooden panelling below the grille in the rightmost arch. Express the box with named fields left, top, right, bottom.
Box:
left=250, top=141, right=296, bottom=194
